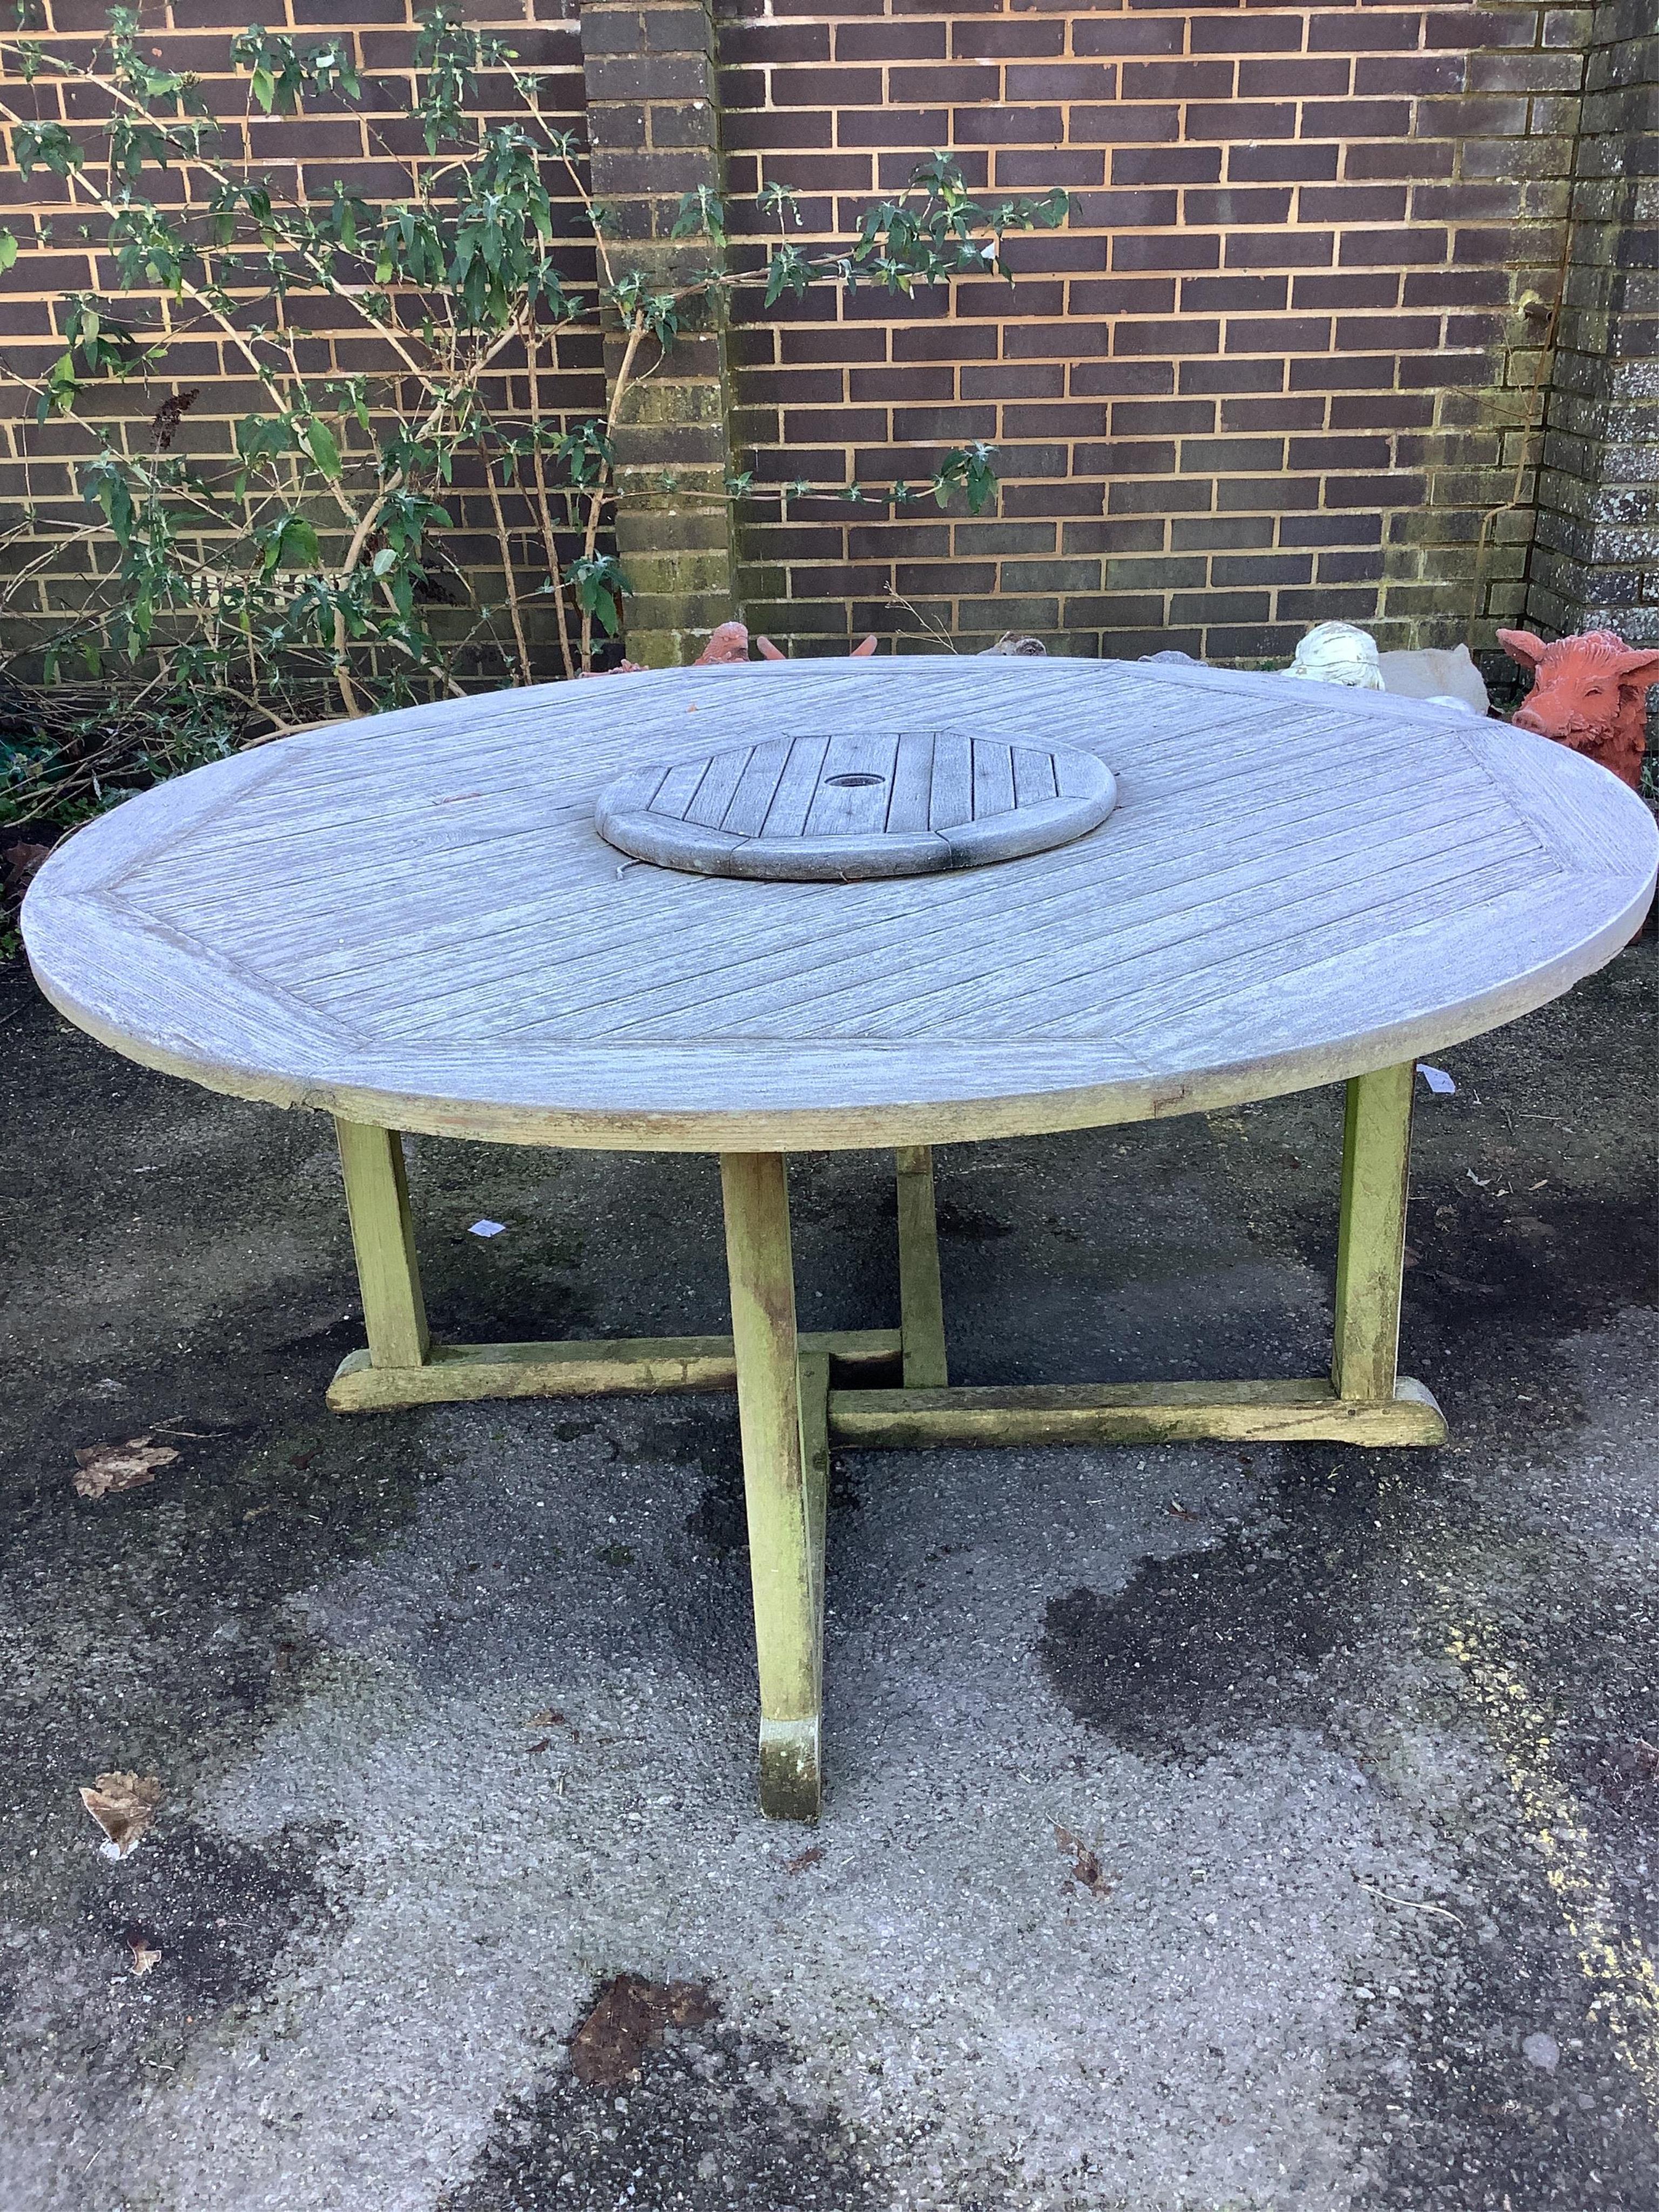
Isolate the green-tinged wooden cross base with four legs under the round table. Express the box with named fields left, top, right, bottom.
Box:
left=327, top=1062, right=1447, bottom=1820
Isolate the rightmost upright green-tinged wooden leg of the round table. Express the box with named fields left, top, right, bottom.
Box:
left=1332, top=1060, right=1415, bottom=1400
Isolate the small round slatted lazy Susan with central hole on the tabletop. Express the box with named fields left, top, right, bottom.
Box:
left=593, top=728, right=1117, bottom=882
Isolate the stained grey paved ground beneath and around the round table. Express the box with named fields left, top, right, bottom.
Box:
left=0, top=940, right=1659, bottom=2212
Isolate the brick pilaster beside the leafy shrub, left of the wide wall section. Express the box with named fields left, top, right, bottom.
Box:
left=582, top=0, right=737, bottom=668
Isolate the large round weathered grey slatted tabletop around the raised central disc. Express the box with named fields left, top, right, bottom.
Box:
left=24, top=657, right=1659, bottom=1152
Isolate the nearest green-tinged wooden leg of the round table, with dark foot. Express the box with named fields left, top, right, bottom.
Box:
left=721, top=1152, right=827, bottom=1820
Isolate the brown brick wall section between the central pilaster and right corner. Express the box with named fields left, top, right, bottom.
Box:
left=721, top=0, right=1590, bottom=659
